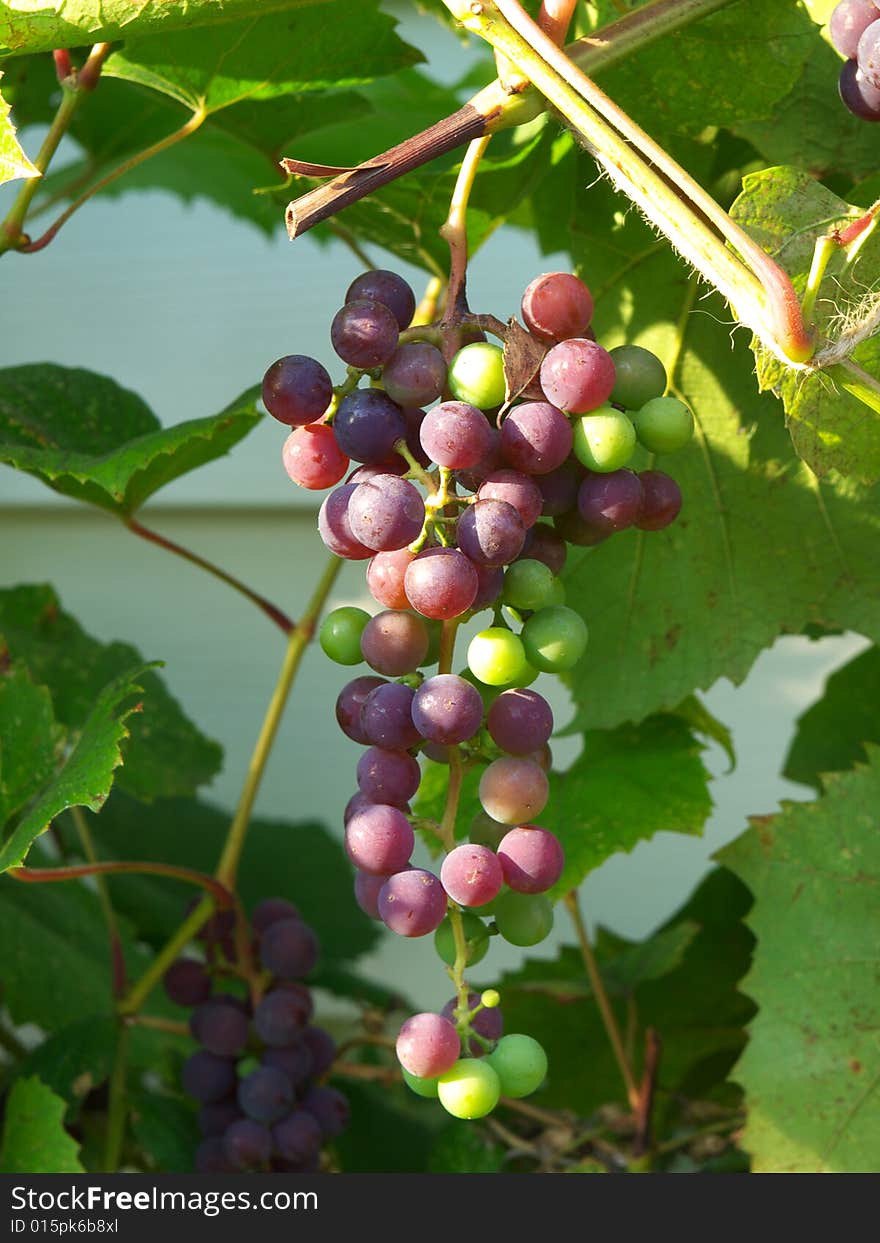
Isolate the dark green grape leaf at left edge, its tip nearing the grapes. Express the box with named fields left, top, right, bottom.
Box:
left=0, top=363, right=260, bottom=517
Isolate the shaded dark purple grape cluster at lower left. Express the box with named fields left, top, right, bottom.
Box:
left=164, top=897, right=348, bottom=1173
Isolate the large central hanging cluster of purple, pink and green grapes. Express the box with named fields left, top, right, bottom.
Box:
left=262, top=271, right=694, bottom=1119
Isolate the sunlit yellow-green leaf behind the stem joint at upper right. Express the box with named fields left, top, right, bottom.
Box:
left=731, top=168, right=880, bottom=484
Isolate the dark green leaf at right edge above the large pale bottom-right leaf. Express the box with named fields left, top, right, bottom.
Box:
left=782, top=648, right=880, bottom=791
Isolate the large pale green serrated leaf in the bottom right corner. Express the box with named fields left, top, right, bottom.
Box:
left=721, top=747, right=880, bottom=1173
